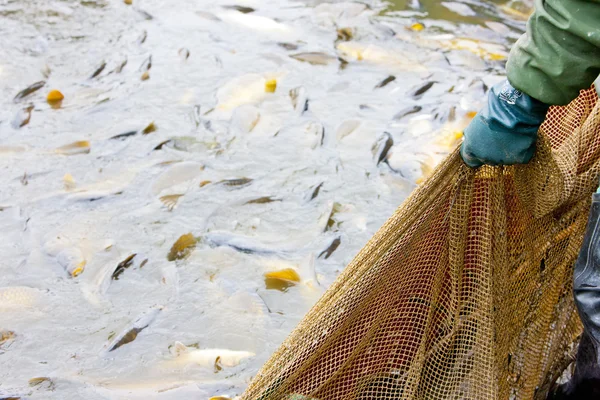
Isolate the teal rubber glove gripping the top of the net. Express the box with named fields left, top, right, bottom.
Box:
left=460, top=80, right=550, bottom=167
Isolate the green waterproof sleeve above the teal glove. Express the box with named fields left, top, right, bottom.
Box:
left=506, top=0, right=600, bottom=105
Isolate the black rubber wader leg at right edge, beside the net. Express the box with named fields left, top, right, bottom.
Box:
left=549, top=193, right=600, bottom=400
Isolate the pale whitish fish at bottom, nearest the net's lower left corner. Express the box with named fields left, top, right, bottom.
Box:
left=169, top=342, right=256, bottom=369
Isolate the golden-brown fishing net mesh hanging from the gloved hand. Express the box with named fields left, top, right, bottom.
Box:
left=242, top=88, right=600, bottom=400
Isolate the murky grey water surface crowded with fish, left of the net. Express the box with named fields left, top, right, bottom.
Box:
left=0, top=0, right=527, bottom=400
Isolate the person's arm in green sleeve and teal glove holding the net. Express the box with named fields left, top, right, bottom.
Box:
left=461, top=0, right=600, bottom=167
